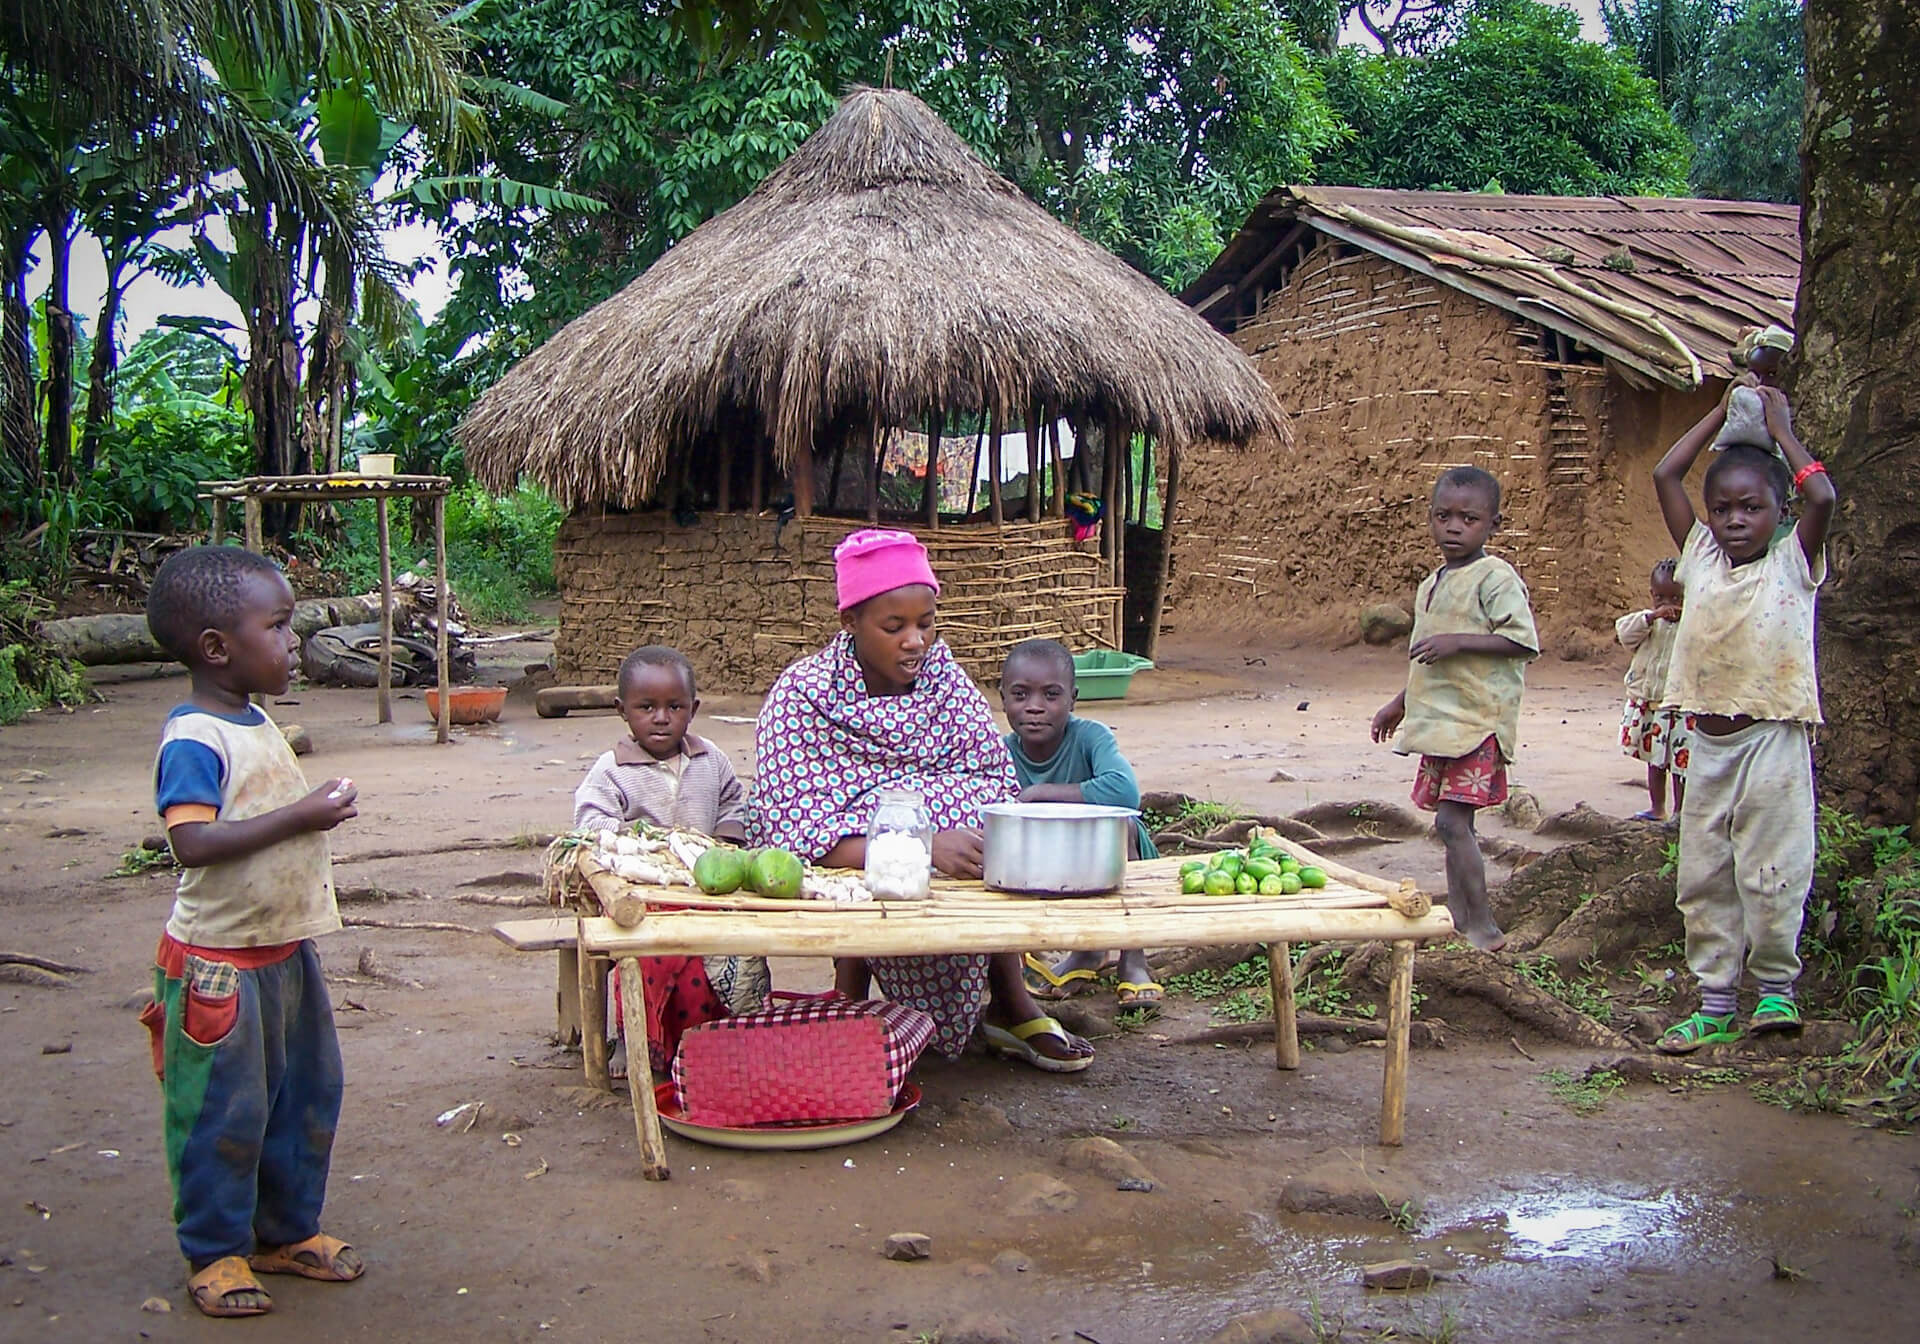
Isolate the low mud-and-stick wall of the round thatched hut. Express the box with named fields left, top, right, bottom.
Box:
left=555, top=513, right=1121, bottom=693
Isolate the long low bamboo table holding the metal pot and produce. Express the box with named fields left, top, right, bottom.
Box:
left=563, top=841, right=1453, bottom=1181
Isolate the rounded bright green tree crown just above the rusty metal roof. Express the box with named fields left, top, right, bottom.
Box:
left=1319, top=0, right=1688, bottom=196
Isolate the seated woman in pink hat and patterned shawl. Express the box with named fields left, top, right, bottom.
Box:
left=749, top=530, right=1092, bottom=1073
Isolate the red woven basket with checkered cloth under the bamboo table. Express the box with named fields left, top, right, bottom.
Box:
left=674, top=991, right=933, bottom=1127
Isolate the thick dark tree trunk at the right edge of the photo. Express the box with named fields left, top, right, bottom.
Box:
left=1791, top=0, right=1920, bottom=824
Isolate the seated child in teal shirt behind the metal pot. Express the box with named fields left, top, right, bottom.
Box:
left=1000, top=639, right=1165, bottom=1008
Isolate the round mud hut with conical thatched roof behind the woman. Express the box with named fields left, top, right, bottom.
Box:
left=461, top=88, right=1288, bottom=691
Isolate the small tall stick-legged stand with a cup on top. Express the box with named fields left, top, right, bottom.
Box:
left=200, top=472, right=453, bottom=741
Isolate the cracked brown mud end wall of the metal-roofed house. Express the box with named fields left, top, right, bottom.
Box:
left=1169, top=242, right=1563, bottom=624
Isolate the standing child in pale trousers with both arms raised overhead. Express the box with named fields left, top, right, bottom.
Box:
left=1653, top=355, right=1836, bottom=1054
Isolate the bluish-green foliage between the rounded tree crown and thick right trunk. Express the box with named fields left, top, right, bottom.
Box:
left=1601, top=0, right=1807, bottom=202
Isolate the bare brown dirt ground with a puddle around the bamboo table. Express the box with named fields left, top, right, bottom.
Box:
left=0, top=643, right=1920, bottom=1344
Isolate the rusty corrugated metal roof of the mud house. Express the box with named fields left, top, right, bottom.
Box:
left=1181, top=186, right=1801, bottom=388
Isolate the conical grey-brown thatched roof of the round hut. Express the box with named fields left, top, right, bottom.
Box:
left=461, top=88, right=1288, bottom=507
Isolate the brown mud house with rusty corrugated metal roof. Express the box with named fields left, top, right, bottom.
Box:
left=1169, top=186, right=1801, bottom=653
